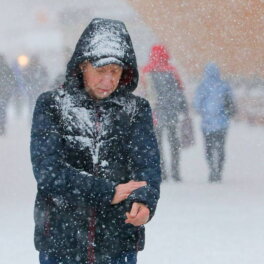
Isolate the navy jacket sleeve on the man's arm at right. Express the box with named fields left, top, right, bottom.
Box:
left=126, top=99, right=161, bottom=218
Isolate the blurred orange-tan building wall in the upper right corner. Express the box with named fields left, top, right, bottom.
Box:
left=127, top=0, right=264, bottom=77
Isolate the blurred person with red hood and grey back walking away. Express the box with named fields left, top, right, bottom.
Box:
left=143, top=45, right=189, bottom=181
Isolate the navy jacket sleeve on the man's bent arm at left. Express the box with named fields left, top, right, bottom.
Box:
left=30, top=92, right=115, bottom=206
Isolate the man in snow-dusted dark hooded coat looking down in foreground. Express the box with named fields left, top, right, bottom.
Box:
left=31, top=18, right=161, bottom=264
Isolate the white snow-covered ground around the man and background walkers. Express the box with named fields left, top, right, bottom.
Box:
left=0, top=106, right=264, bottom=264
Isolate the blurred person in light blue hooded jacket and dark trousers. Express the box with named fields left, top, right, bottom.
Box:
left=194, top=63, right=235, bottom=182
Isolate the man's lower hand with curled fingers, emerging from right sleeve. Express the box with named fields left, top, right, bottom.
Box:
left=125, top=203, right=150, bottom=226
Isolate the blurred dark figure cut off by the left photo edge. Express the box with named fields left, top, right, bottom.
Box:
left=0, top=55, right=16, bottom=135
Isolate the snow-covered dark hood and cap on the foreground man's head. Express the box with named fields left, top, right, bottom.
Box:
left=66, top=18, right=138, bottom=92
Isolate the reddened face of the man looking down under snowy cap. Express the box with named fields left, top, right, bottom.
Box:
left=80, top=62, right=123, bottom=99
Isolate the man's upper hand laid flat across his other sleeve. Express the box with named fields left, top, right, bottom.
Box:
left=111, top=181, right=147, bottom=204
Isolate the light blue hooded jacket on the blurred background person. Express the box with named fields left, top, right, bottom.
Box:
left=194, top=63, right=234, bottom=133
